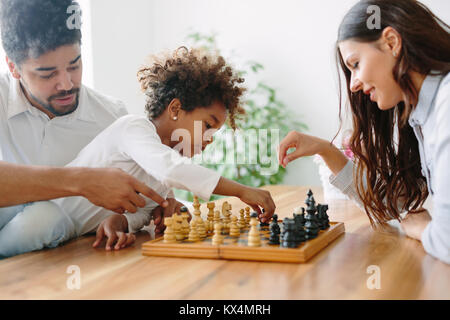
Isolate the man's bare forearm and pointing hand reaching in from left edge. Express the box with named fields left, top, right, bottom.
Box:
left=0, top=161, right=167, bottom=213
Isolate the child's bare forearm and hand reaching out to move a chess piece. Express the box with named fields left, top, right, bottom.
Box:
left=213, top=177, right=275, bottom=222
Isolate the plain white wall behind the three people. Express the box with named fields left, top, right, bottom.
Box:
left=90, top=0, right=450, bottom=185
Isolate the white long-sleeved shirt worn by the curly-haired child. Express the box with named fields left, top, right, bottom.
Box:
left=53, top=115, right=220, bottom=235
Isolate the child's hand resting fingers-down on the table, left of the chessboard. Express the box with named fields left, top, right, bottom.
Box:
left=92, top=214, right=136, bottom=251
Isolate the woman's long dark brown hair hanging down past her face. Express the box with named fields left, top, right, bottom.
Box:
left=336, top=0, right=450, bottom=225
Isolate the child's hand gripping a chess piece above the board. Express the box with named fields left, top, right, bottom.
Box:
left=239, top=187, right=275, bottom=222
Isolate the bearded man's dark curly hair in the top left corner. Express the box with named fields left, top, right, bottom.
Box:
left=0, top=0, right=81, bottom=65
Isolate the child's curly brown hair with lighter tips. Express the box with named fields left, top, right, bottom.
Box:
left=137, top=47, right=245, bottom=129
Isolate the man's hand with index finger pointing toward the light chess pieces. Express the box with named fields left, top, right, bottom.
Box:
left=75, top=168, right=168, bottom=213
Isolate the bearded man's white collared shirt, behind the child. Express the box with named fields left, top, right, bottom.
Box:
left=0, top=73, right=127, bottom=166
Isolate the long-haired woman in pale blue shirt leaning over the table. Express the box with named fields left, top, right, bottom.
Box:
left=279, top=0, right=450, bottom=263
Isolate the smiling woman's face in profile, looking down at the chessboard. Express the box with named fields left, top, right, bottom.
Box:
left=339, top=39, right=404, bottom=110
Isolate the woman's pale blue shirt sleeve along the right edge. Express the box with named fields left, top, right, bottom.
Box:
left=422, top=77, right=450, bottom=264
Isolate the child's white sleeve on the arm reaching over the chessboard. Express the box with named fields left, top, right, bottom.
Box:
left=119, top=117, right=220, bottom=201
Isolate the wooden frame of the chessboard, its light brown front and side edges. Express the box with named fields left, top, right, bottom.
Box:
left=142, top=221, right=345, bottom=263
